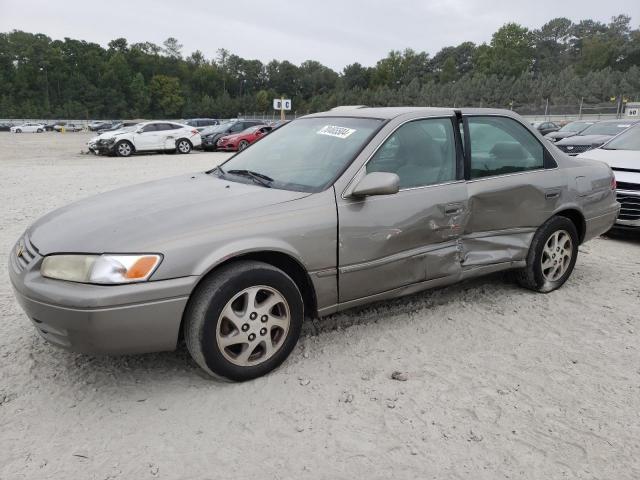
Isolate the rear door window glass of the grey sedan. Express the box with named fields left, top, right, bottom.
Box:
left=468, top=117, right=544, bottom=178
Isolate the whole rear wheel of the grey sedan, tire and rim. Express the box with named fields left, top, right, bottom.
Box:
left=516, top=216, right=579, bottom=293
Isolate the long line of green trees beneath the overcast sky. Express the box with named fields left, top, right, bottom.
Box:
left=0, top=15, right=640, bottom=119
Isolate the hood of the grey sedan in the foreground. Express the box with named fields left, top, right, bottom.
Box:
left=28, top=173, right=309, bottom=255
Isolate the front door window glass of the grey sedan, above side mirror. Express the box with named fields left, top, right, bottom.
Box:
left=367, top=118, right=456, bottom=188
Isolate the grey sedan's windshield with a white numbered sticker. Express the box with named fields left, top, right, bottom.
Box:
left=215, top=117, right=383, bottom=192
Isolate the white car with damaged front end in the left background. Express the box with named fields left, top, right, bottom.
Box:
left=87, top=121, right=202, bottom=157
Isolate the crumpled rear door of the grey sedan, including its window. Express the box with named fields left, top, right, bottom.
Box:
left=462, top=115, right=565, bottom=268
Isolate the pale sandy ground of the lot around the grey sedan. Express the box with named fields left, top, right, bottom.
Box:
left=0, top=133, right=640, bottom=480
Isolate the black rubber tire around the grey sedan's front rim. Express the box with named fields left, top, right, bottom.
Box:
left=184, top=261, right=304, bottom=381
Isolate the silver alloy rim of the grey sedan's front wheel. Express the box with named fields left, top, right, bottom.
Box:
left=216, top=285, right=291, bottom=367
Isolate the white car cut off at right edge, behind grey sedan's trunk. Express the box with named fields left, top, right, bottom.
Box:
left=577, top=124, right=640, bottom=229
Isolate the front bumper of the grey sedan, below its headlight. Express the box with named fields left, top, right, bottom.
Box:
left=9, top=235, right=197, bottom=354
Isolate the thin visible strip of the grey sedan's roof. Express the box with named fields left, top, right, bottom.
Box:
left=302, top=106, right=518, bottom=120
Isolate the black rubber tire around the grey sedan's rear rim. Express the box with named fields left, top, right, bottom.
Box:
left=515, top=216, right=580, bottom=293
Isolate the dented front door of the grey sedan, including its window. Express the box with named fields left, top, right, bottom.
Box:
left=338, top=118, right=467, bottom=303
